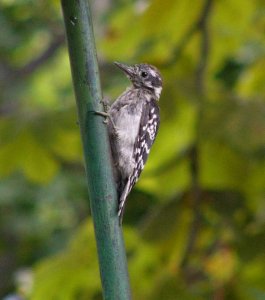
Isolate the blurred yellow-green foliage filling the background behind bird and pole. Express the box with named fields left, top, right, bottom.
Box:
left=0, top=0, right=265, bottom=300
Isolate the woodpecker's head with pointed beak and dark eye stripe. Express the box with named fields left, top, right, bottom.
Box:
left=114, top=62, right=162, bottom=100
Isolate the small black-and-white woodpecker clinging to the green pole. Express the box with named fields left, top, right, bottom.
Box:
left=108, top=62, right=162, bottom=224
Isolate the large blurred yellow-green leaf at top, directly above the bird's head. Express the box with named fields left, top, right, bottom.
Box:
left=102, top=0, right=203, bottom=61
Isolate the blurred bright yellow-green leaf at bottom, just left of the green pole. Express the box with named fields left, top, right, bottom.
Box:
left=31, top=222, right=101, bottom=300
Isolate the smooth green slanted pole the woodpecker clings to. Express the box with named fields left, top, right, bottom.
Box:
left=61, top=0, right=131, bottom=300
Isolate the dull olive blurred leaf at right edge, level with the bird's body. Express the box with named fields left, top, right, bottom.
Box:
left=202, top=99, right=265, bottom=155
